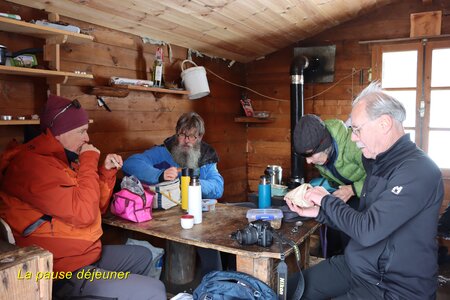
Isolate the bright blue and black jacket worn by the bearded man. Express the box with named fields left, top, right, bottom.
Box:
left=123, top=136, right=223, bottom=199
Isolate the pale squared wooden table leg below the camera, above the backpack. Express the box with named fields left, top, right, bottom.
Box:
left=236, top=255, right=276, bottom=286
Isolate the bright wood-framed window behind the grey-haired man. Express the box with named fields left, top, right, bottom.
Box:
left=372, top=40, right=450, bottom=174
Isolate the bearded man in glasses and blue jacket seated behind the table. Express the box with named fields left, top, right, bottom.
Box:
left=123, top=112, right=223, bottom=199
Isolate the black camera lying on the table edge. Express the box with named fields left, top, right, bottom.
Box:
left=231, top=220, right=273, bottom=247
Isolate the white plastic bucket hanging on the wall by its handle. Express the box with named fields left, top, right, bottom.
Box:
left=181, top=59, right=209, bottom=100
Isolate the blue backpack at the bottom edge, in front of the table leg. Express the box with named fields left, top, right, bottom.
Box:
left=193, top=271, right=278, bottom=300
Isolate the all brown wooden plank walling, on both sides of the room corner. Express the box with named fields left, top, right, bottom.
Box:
left=0, top=0, right=450, bottom=206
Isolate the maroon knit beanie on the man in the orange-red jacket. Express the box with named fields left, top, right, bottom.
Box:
left=40, top=95, right=89, bottom=136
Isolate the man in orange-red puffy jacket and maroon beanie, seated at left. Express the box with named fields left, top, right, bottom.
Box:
left=0, top=96, right=166, bottom=299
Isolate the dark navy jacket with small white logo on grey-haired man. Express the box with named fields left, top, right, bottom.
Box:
left=317, top=134, right=444, bottom=300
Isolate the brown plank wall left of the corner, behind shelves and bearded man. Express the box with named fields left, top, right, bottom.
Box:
left=0, top=1, right=247, bottom=202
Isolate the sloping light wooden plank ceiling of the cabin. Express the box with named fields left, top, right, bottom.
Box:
left=8, top=0, right=400, bottom=63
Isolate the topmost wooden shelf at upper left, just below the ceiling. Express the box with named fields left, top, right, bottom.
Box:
left=0, top=17, right=94, bottom=44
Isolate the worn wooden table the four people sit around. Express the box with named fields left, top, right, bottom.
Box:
left=103, top=204, right=320, bottom=285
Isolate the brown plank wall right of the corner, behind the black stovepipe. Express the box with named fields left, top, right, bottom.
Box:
left=246, top=0, right=450, bottom=211
